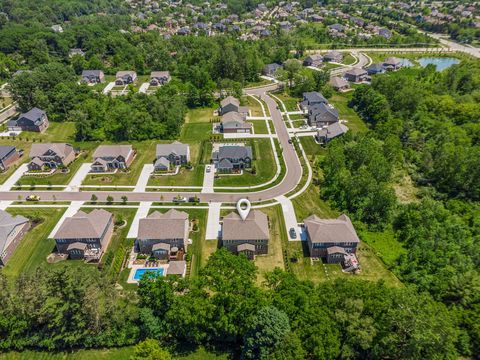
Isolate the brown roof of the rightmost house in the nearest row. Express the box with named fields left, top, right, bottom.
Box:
left=304, top=214, right=360, bottom=243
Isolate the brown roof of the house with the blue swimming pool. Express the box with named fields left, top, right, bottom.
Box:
left=137, top=209, right=188, bottom=240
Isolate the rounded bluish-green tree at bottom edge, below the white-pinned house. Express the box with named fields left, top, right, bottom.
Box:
left=241, top=306, right=290, bottom=359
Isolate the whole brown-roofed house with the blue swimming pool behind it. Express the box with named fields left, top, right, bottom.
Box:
left=135, top=209, right=189, bottom=260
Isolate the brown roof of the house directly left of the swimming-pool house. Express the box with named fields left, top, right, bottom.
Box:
left=54, top=209, right=113, bottom=239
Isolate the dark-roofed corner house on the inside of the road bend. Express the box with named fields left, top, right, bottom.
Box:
left=213, top=145, right=252, bottom=172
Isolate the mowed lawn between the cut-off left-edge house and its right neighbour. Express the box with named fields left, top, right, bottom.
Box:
left=2, top=208, right=65, bottom=278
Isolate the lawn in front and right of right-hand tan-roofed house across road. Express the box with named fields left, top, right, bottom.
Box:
left=83, top=140, right=157, bottom=186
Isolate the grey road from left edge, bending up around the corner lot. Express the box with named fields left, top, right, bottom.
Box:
left=0, top=84, right=302, bottom=203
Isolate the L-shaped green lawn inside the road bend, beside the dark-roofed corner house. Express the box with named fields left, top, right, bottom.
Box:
left=215, top=139, right=277, bottom=186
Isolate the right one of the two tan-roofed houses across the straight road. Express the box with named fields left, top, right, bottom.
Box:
left=91, top=145, right=135, bottom=172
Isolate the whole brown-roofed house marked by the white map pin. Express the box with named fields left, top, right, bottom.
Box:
left=222, top=210, right=270, bottom=260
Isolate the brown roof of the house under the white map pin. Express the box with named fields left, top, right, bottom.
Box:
left=222, top=210, right=270, bottom=240
